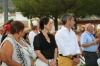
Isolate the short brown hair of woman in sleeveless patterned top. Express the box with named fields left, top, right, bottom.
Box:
left=10, top=21, right=24, bottom=34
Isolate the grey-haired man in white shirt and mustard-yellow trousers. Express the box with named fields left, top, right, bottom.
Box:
left=55, top=14, right=80, bottom=66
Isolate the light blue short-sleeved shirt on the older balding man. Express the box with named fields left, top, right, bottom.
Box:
left=80, top=31, right=98, bottom=52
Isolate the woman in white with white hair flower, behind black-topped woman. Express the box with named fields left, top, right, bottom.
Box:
left=29, top=20, right=39, bottom=54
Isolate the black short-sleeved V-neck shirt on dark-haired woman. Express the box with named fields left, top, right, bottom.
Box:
left=33, top=32, right=57, bottom=59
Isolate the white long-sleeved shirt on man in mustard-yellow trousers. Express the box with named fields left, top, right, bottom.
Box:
left=55, top=27, right=80, bottom=56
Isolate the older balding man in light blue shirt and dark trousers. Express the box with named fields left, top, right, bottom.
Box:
left=81, top=23, right=100, bottom=66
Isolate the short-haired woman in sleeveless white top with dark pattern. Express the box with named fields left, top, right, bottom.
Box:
left=1, top=21, right=33, bottom=66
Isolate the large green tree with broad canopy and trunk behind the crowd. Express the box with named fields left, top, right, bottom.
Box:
left=13, top=0, right=100, bottom=30
